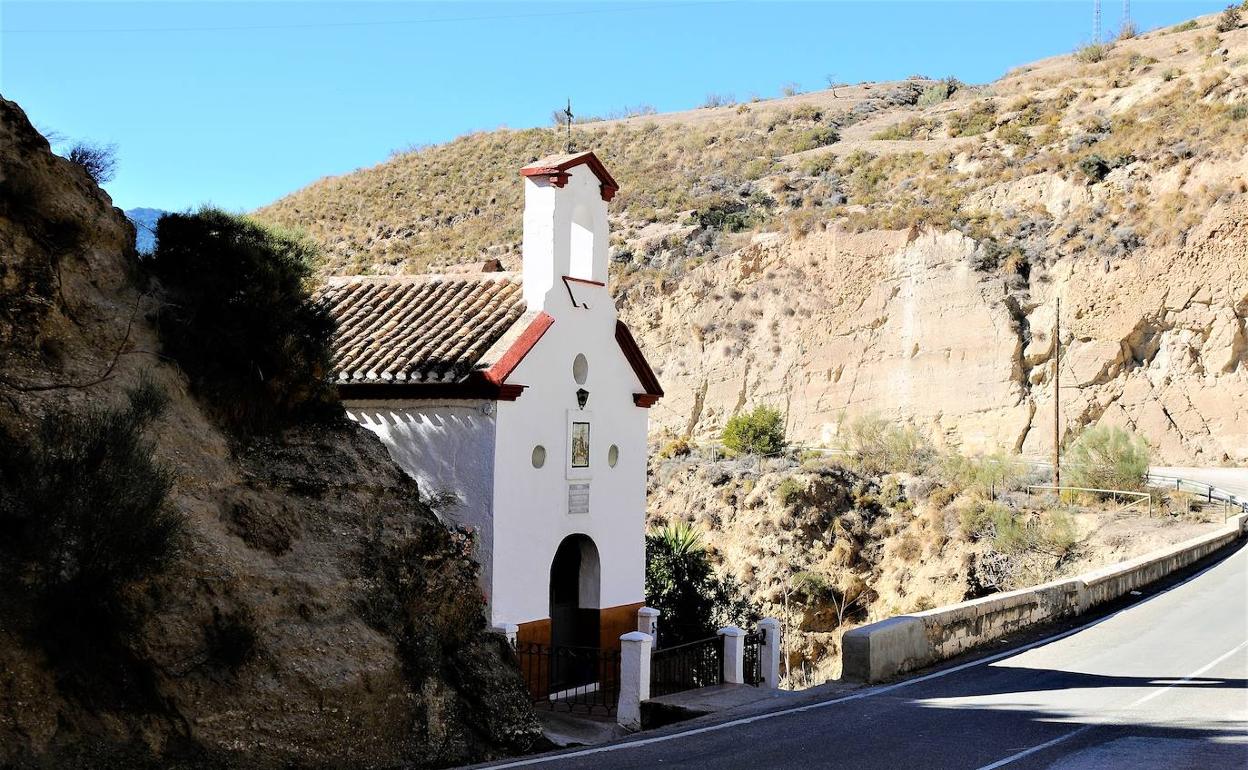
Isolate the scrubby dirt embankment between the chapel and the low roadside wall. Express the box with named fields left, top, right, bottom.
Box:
left=648, top=458, right=1222, bottom=686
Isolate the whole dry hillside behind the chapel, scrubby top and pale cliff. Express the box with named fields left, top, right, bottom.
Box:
left=258, top=16, right=1248, bottom=464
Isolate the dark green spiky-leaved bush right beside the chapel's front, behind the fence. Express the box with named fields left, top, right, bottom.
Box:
left=645, top=522, right=756, bottom=646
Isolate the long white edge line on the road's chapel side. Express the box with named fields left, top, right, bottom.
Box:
left=488, top=559, right=1243, bottom=770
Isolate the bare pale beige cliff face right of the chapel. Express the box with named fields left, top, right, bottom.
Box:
left=626, top=201, right=1248, bottom=464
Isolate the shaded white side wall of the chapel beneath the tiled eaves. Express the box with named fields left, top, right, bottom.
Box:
left=344, top=401, right=497, bottom=594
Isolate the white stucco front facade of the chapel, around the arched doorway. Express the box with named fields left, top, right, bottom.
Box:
left=492, top=160, right=648, bottom=624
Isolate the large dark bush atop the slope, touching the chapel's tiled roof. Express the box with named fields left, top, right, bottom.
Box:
left=152, top=208, right=337, bottom=434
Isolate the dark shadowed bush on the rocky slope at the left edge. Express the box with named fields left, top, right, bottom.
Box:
left=0, top=384, right=185, bottom=688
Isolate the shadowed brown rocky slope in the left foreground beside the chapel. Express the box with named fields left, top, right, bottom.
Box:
left=0, top=101, right=539, bottom=768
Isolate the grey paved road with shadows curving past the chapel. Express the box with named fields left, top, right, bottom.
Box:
left=491, top=548, right=1248, bottom=770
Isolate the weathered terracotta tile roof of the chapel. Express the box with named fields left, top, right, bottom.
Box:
left=321, top=272, right=525, bottom=383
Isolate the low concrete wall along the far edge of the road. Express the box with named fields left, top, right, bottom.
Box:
left=841, top=514, right=1248, bottom=681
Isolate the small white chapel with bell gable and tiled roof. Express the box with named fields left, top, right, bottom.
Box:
left=323, top=152, right=663, bottom=648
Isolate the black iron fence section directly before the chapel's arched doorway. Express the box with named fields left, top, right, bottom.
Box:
left=515, top=641, right=620, bottom=715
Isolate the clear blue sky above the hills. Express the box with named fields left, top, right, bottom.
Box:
left=0, top=0, right=1227, bottom=210
